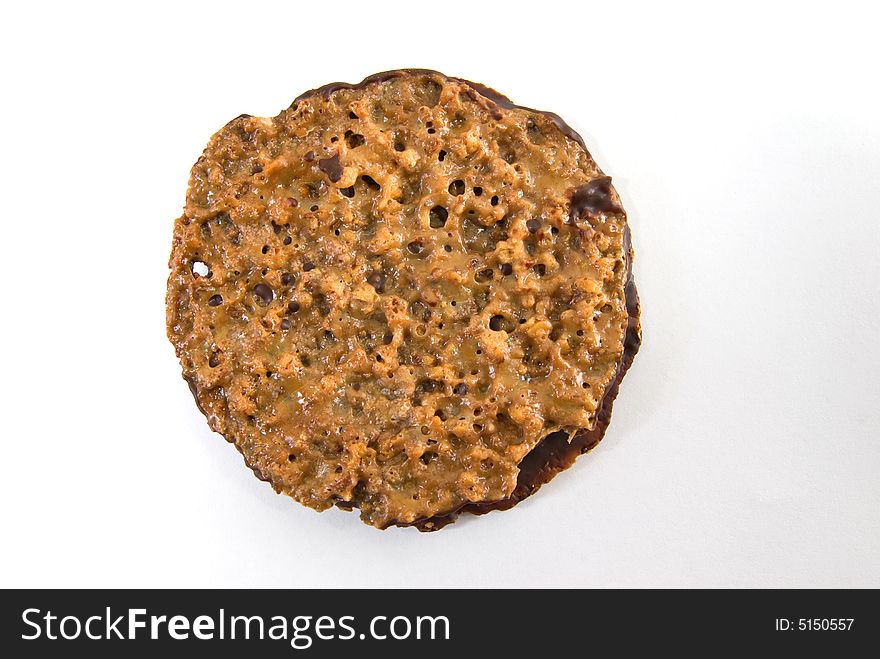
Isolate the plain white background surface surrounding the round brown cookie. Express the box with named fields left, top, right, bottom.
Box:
left=0, top=0, right=880, bottom=587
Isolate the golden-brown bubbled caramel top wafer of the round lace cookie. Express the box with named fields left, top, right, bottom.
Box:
left=167, top=73, right=629, bottom=528
